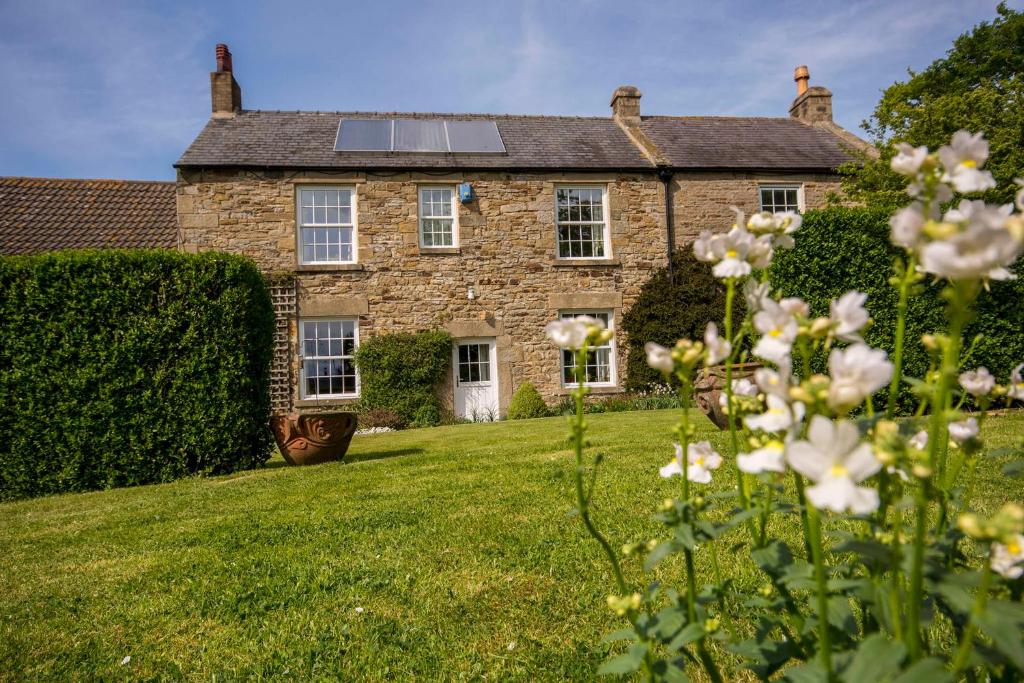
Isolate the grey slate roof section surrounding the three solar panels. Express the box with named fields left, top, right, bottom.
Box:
left=175, top=111, right=652, bottom=170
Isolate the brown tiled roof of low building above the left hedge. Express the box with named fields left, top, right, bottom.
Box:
left=0, top=177, right=177, bottom=254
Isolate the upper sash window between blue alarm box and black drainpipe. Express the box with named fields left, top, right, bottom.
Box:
left=555, top=186, right=608, bottom=258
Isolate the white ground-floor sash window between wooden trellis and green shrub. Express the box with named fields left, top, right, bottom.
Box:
left=299, top=319, right=359, bottom=398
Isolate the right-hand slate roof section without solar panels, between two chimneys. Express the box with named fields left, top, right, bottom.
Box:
left=640, top=116, right=852, bottom=170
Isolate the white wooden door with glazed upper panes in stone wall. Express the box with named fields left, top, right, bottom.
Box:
left=452, top=338, right=498, bottom=422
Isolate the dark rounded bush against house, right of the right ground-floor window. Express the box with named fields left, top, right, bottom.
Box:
left=621, top=245, right=745, bottom=392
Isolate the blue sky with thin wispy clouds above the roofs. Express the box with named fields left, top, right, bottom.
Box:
left=0, top=0, right=1024, bottom=179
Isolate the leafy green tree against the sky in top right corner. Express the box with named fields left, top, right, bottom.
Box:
left=841, top=3, right=1024, bottom=207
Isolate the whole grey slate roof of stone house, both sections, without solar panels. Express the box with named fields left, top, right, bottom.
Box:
left=175, top=111, right=851, bottom=171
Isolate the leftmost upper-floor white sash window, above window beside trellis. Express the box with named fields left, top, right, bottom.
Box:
left=299, top=187, right=355, bottom=263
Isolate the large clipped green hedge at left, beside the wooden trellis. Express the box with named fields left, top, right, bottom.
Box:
left=0, top=251, right=273, bottom=499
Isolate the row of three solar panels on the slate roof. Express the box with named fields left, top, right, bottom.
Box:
left=334, top=119, right=505, bottom=155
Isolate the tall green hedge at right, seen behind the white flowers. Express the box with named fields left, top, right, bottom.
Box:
left=770, top=208, right=1024, bottom=411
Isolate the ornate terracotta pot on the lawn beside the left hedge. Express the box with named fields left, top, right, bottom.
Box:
left=270, top=413, right=356, bottom=465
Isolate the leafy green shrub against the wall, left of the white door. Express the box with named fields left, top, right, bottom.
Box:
left=355, top=331, right=452, bottom=427
